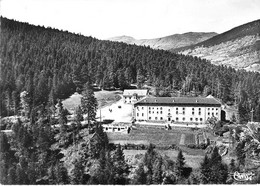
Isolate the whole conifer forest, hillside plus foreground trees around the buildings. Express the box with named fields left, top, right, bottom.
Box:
left=0, top=17, right=260, bottom=184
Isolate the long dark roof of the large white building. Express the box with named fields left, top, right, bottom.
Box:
left=134, top=97, right=221, bottom=107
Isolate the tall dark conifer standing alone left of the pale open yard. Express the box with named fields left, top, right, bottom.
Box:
left=81, top=83, right=97, bottom=130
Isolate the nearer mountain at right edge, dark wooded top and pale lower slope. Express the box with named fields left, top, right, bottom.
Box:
left=175, top=20, right=260, bottom=72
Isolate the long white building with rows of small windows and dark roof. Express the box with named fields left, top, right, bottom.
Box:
left=133, top=97, right=221, bottom=123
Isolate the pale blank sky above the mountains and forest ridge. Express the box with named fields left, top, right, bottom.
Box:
left=0, top=0, right=260, bottom=39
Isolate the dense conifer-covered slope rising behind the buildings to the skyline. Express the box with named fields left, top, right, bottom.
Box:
left=0, top=17, right=260, bottom=120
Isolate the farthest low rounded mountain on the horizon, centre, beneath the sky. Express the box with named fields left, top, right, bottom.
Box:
left=108, top=32, right=217, bottom=50
